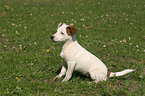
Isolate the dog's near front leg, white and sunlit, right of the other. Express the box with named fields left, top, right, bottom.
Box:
left=62, top=62, right=75, bottom=82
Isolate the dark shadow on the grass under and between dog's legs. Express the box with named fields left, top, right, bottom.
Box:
left=55, top=67, right=92, bottom=81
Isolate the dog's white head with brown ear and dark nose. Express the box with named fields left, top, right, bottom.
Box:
left=51, top=23, right=77, bottom=42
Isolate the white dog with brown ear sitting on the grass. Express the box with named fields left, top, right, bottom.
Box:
left=51, top=23, right=135, bottom=83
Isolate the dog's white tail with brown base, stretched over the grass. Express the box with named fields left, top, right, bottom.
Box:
left=107, top=69, right=135, bottom=77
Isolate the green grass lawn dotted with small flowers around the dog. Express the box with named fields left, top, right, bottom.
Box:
left=0, top=0, right=145, bottom=96
